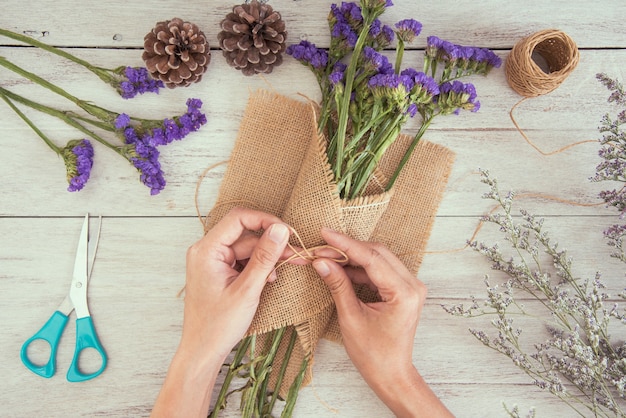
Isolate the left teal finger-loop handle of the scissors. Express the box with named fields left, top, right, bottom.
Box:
left=20, top=311, right=68, bottom=377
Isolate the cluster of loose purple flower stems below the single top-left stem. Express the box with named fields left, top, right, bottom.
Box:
left=0, top=57, right=207, bottom=195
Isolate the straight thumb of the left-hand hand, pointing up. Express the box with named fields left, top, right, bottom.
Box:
left=237, top=223, right=289, bottom=294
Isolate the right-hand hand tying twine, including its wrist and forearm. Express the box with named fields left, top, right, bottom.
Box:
left=313, top=229, right=452, bottom=417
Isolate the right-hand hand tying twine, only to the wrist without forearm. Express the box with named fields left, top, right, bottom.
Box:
left=313, top=229, right=426, bottom=383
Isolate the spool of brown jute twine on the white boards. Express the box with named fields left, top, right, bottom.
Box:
left=505, top=29, right=579, bottom=97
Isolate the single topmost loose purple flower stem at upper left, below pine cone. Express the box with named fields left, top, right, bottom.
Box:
left=0, top=28, right=165, bottom=99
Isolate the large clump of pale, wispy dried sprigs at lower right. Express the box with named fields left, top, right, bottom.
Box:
left=444, top=171, right=626, bottom=417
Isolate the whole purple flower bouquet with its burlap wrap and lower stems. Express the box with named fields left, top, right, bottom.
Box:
left=205, top=0, right=500, bottom=416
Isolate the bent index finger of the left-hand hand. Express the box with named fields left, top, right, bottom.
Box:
left=207, top=208, right=282, bottom=246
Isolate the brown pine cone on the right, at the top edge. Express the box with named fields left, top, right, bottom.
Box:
left=217, top=0, right=287, bottom=75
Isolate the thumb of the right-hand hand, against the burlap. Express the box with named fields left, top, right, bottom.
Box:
left=313, top=258, right=359, bottom=318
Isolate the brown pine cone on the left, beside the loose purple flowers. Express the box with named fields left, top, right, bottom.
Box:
left=142, top=18, right=211, bottom=88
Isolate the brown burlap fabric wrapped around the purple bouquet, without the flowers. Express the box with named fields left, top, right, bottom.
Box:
left=206, top=91, right=454, bottom=394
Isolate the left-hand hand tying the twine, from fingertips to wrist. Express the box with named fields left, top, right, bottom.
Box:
left=181, top=208, right=290, bottom=359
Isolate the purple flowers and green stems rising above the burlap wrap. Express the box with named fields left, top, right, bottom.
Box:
left=286, top=0, right=501, bottom=198
